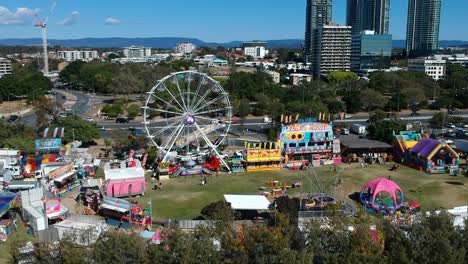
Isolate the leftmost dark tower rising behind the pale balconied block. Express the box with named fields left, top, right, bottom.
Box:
left=304, top=0, right=332, bottom=63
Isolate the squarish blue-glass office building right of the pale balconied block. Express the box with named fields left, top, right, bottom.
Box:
left=351, top=30, right=392, bottom=71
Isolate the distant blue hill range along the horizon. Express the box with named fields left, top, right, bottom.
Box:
left=0, top=37, right=468, bottom=49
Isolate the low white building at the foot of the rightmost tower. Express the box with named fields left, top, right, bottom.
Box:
left=408, top=58, right=446, bottom=81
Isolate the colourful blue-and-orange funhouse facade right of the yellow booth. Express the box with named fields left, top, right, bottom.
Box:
left=280, top=122, right=339, bottom=166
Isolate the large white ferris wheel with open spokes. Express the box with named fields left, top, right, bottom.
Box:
left=143, top=71, right=232, bottom=167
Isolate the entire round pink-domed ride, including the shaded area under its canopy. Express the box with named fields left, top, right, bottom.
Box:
left=359, top=178, right=404, bottom=214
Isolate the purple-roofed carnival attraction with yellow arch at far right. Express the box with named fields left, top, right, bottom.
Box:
left=403, top=138, right=460, bottom=174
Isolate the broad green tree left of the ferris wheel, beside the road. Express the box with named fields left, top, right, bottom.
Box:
left=51, top=116, right=100, bottom=144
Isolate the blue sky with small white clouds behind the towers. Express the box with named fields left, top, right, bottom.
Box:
left=0, top=0, right=468, bottom=42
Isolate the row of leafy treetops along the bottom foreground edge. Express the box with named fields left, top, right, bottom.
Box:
left=10, top=202, right=468, bottom=264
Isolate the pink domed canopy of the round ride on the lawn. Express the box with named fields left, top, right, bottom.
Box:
left=360, top=178, right=403, bottom=208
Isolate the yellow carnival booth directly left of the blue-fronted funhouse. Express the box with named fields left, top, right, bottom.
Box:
left=243, top=142, right=283, bottom=171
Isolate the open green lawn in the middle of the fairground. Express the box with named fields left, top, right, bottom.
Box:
left=139, top=164, right=468, bottom=220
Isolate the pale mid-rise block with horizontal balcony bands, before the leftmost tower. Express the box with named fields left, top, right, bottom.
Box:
left=312, top=24, right=351, bottom=76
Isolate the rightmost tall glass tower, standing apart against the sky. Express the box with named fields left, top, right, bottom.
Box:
left=406, top=0, right=442, bottom=56
